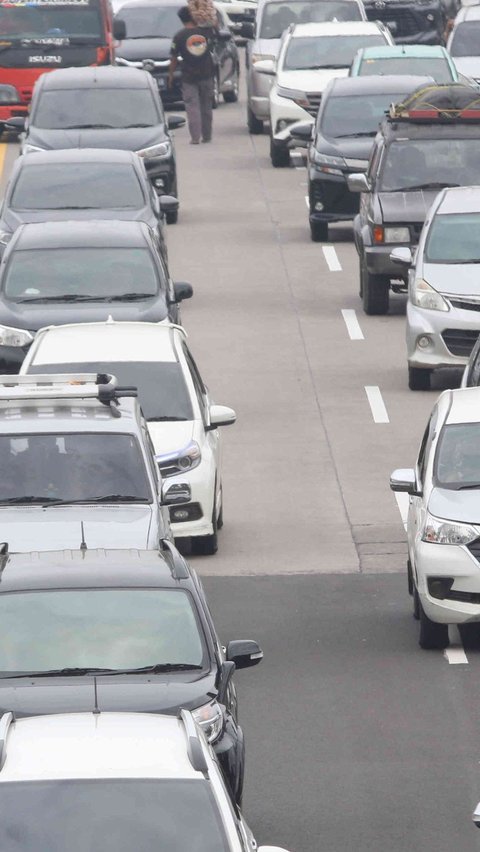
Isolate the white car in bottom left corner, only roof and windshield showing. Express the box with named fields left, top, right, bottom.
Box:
left=0, top=704, right=292, bottom=852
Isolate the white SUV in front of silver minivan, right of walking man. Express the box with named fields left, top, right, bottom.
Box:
left=255, top=21, right=394, bottom=166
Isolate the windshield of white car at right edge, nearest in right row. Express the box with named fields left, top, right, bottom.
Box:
left=435, top=423, right=480, bottom=490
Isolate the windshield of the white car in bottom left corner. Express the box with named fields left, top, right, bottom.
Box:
left=0, top=780, right=231, bottom=852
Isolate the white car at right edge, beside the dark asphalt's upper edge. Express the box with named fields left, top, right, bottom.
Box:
left=390, top=388, right=480, bottom=648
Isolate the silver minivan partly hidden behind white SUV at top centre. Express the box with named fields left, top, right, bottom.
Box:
left=246, top=0, right=367, bottom=133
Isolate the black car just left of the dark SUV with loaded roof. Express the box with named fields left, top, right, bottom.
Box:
left=292, top=76, right=431, bottom=242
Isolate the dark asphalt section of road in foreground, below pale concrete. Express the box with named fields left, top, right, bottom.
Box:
left=205, top=575, right=480, bottom=852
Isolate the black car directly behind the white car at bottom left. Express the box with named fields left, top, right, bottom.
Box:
left=0, top=541, right=263, bottom=803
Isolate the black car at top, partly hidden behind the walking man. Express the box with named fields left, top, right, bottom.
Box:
left=115, top=0, right=240, bottom=107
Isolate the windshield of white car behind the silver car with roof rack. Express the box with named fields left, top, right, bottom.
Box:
left=28, top=362, right=193, bottom=420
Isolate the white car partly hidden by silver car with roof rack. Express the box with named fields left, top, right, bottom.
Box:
left=21, top=321, right=236, bottom=554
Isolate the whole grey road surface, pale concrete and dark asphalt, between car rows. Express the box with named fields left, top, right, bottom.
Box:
left=0, top=66, right=480, bottom=852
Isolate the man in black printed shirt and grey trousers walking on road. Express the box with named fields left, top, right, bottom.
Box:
left=168, top=6, right=215, bottom=145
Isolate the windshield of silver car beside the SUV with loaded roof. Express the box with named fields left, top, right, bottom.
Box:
left=424, top=213, right=480, bottom=265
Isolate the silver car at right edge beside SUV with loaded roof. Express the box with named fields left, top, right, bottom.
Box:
left=391, top=186, right=480, bottom=390
